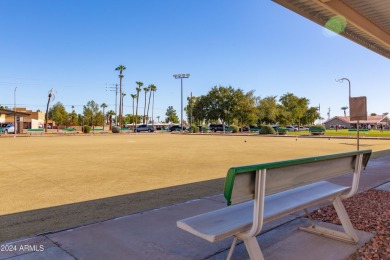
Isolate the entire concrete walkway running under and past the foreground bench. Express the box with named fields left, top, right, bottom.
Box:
left=0, top=156, right=390, bottom=260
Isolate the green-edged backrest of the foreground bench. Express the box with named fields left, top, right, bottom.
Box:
left=224, top=150, right=371, bottom=205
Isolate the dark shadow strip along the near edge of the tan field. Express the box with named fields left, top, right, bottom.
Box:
left=0, top=178, right=224, bottom=242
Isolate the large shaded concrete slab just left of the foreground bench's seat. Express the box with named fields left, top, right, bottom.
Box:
left=47, top=199, right=232, bottom=259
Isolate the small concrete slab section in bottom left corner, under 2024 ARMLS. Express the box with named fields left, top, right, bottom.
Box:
left=0, top=236, right=74, bottom=260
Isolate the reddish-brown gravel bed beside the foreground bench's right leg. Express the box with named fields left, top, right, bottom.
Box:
left=310, top=190, right=390, bottom=260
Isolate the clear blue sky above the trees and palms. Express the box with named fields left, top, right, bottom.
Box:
left=0, top=0, right=390, bottom=120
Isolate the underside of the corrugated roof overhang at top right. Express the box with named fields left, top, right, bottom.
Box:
left=273, top=0, right=390, bottom=58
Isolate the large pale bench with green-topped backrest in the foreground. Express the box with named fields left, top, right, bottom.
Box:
left=177, top=150, right=371, bottom=259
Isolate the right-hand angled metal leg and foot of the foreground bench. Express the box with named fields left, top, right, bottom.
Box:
left=299, top=197, right=359, bottom=244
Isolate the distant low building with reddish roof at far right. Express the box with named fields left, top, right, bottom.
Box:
left=324, top=116, right=390, bottom=129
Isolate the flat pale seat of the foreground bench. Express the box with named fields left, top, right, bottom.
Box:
left=177, top=181, right=350, bottom=242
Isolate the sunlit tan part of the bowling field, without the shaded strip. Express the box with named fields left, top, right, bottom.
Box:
left=0, top=134, right=390, bottom=215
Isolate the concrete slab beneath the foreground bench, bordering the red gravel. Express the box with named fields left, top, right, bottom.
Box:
left=209, top=218, right=374, bottom=260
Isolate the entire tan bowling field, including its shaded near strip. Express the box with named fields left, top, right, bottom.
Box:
left=0, top=133, right=390, bottom=241
